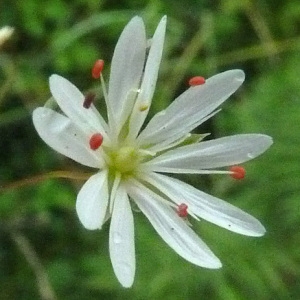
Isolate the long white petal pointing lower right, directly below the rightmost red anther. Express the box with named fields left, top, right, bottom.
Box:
left=144, top=173, right=266, bottom=236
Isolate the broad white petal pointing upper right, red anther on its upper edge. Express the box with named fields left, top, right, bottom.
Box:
left=138, top=70, right=245, bottom=150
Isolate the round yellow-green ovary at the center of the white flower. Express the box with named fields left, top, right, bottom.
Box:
left=109, top=146, right=141, bottom=174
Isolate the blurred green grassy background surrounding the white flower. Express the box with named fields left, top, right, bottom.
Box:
left=0, top=0, right=300, bottom=300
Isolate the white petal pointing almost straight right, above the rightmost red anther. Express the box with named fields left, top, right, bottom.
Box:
left=148, top=134, right=273, bottom=173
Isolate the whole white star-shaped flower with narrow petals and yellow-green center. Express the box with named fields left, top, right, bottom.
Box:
left=33, top=17, right=272, bottom=287
